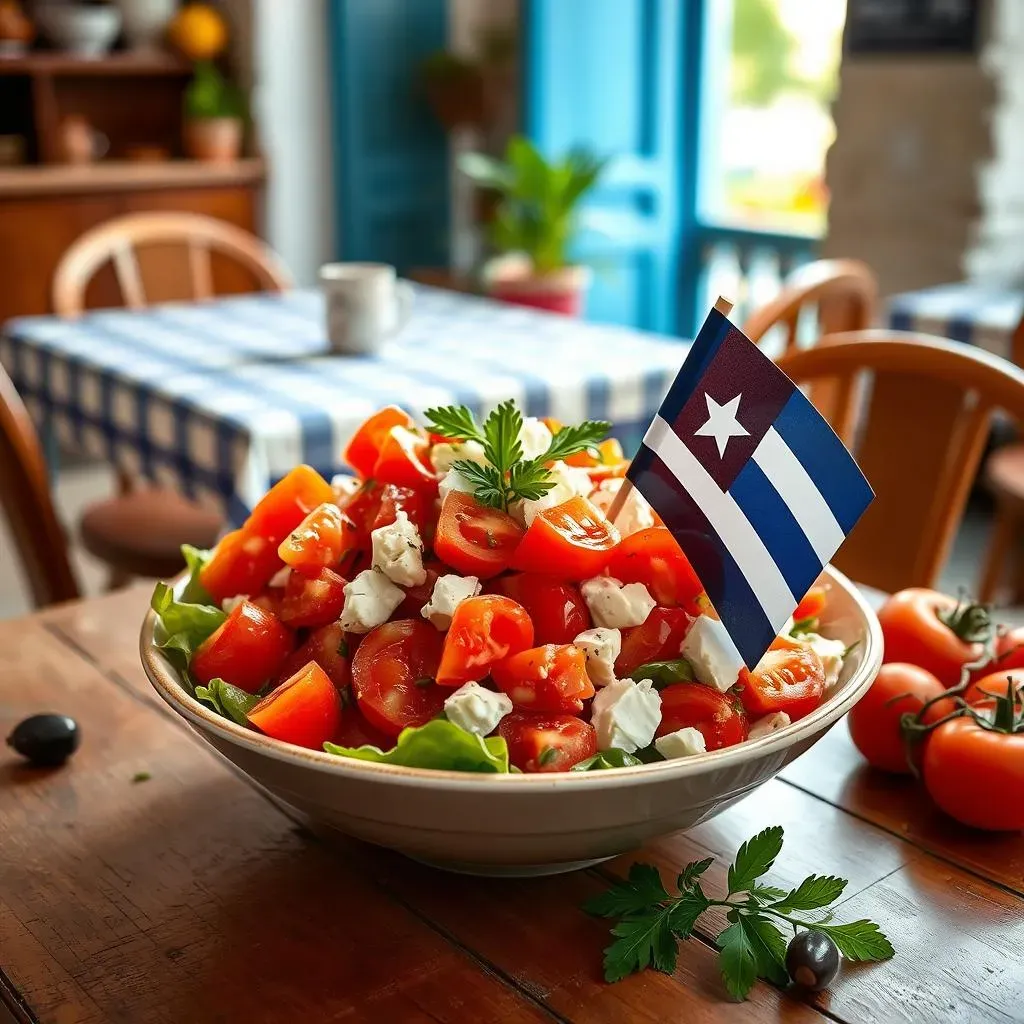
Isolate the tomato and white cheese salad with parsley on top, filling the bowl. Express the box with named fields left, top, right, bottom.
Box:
left=153, top=401, right=847, bottom=772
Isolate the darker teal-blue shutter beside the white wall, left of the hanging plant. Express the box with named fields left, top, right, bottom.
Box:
left=329, top=0, right=450, bottom=271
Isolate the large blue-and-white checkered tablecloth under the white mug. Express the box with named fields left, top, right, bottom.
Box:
left=0, top=287, right=686, bottom=522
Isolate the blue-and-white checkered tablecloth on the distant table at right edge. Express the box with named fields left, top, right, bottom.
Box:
left=888, top=282, right=1024, bottom=358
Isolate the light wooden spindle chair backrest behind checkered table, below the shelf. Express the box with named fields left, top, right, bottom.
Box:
left=53, top=212, right=291, bottom=316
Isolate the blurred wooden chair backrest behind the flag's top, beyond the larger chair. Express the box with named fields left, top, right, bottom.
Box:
left=743, top=259, right=879, bottom=353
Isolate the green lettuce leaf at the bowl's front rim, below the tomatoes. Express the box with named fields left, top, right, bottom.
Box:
left=324, top=718, right=509, bottom=773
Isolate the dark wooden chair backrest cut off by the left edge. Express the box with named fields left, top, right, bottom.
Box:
left=0, top=367, right=79, bottom=607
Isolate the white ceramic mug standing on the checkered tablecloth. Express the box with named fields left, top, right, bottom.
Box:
left=321, top=263, right=413, bottom=355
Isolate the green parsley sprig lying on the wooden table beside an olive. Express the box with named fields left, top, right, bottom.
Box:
left=585, top=825, right=894, bottom=999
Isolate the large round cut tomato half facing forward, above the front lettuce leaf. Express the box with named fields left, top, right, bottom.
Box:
left=352, top=618, right=450, bottom=736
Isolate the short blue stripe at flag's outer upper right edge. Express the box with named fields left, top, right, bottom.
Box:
left=775, top=391, right=873, bottom=536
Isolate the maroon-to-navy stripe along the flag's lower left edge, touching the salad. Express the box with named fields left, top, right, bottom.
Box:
left=630, top=444, right=775, bottom=669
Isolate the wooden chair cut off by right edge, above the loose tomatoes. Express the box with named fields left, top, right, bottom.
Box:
left=978, top=316, right=1024, bottom=604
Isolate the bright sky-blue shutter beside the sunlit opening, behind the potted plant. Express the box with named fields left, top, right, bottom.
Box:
left=523, top=0, right=699, bottom=332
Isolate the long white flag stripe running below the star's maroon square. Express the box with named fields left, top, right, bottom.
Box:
left=644, top=416, right=797, bottom=632
